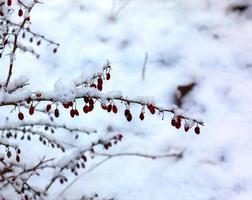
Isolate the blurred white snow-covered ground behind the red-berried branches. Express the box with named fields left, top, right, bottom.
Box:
left=1, top=0, right=252, bottom=200
